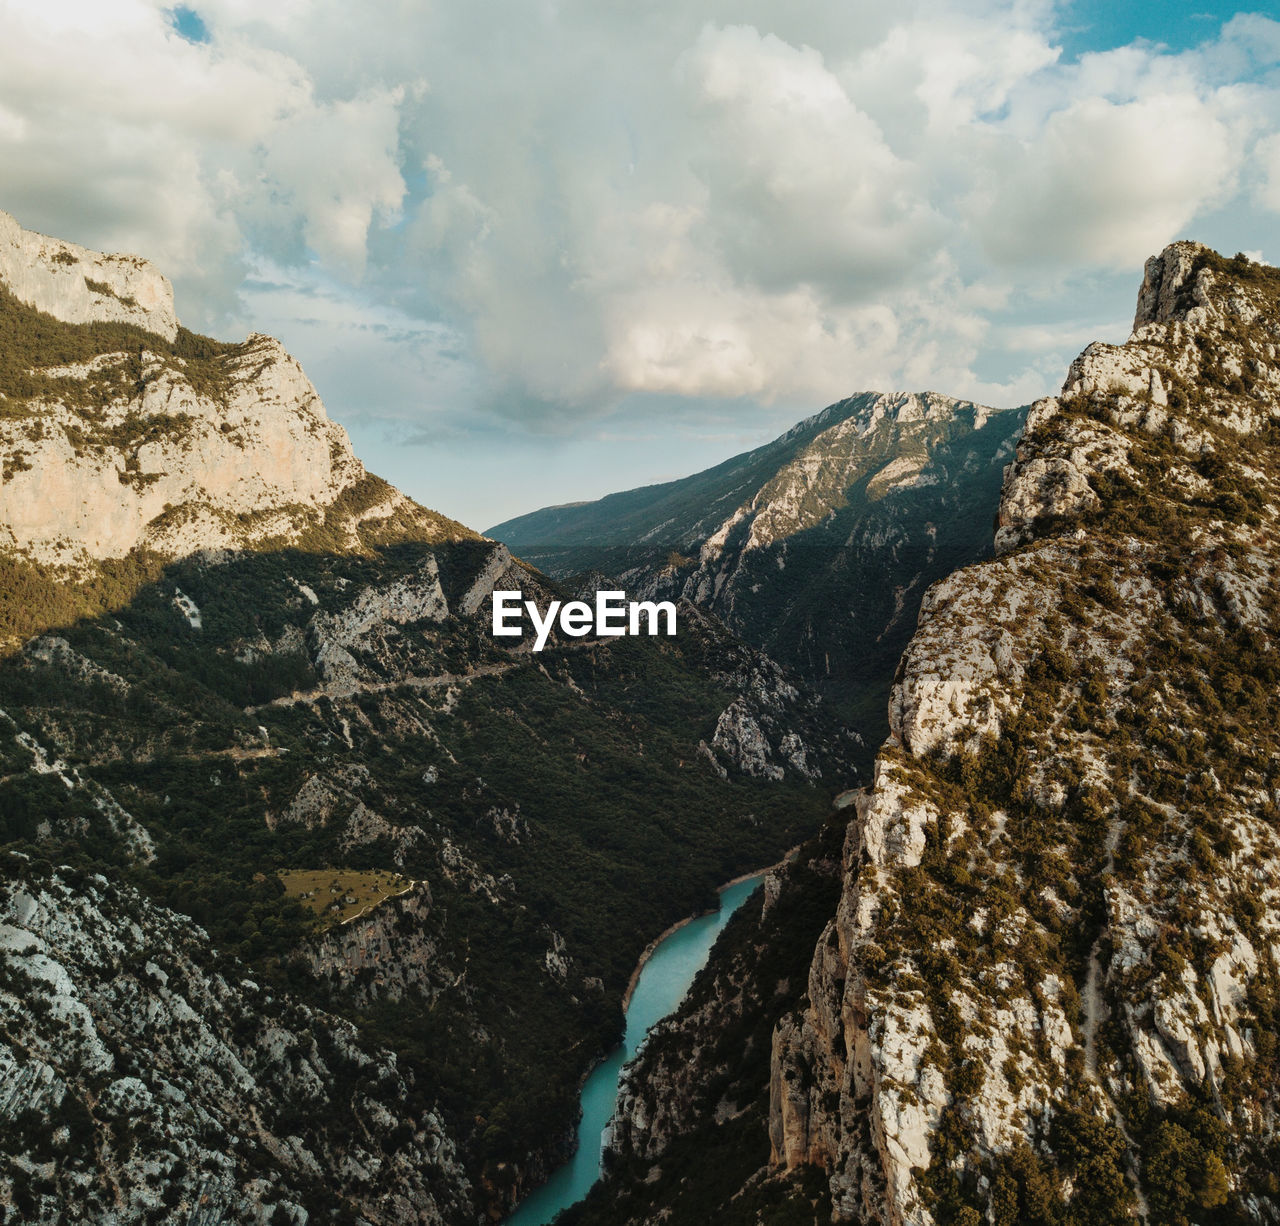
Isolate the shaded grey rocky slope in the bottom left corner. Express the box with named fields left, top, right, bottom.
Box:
left=0, top=856, right=475, bottom=1226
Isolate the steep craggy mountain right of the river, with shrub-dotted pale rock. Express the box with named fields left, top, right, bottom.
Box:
left=570, top=243, right=1280, bottom=1226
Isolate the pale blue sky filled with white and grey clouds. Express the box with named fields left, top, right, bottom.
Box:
left=0, top=0, right=1280, bottom=529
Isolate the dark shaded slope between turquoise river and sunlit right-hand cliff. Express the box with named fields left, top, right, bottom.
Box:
left=572, top=824, right=841, bottom=1226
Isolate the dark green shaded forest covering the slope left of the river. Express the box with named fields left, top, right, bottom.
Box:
left=0, top=540, right=839, bottom=1208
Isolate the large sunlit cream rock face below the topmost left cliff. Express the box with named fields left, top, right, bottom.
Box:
left=0, top=337, right=365, bottom=566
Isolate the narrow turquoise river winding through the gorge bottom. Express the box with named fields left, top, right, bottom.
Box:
left=506, top=873, right=764, bottom=1226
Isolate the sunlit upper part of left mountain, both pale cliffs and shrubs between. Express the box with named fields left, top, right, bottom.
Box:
left=0, top=214, right=471, bottom=573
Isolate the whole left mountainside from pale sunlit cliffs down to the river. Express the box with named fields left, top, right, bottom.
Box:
left=0, top=208, right=854, bottom=1226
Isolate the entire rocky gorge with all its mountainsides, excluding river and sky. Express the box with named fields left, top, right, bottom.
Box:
left=0, top=203, right=1280, bottom=1226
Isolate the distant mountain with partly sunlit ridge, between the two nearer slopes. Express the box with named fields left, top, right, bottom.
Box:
left=488, top=392, right=1025, bottom=744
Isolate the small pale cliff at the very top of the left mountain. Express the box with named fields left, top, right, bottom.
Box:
left=0, top=211, right=178, bottom=340
